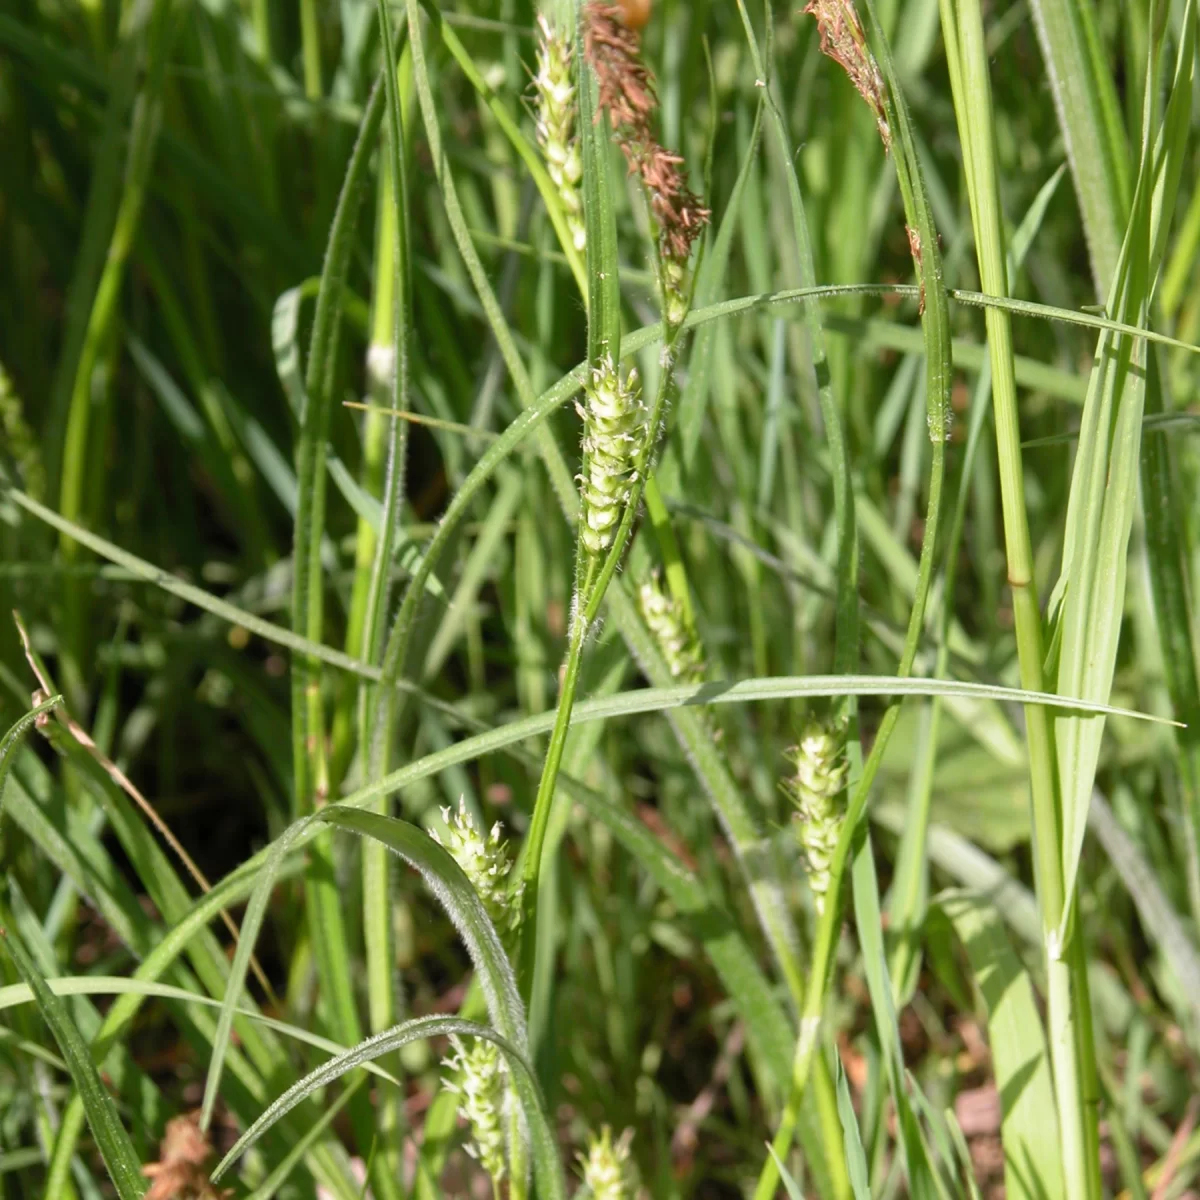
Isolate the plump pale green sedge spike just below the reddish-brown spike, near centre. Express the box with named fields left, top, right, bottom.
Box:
left=578, top=359, right=646, bottom=554
